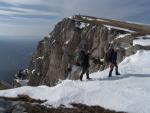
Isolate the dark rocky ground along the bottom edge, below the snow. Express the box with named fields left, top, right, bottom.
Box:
left=0, top=99, right=126, bottom=113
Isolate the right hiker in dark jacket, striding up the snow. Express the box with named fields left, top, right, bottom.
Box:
left=105, top=45, right=120, bottom=77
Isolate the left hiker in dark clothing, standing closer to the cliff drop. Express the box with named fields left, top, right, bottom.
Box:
left=80, top=50, right=91, bottom=81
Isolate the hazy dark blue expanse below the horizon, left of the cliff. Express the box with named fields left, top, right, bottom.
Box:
left=0, top=37, right=39, bottom=83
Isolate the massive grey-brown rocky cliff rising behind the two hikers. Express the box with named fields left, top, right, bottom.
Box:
left=28, top=15, right=149, bottom=86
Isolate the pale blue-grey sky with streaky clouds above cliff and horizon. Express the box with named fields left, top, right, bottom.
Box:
left=0, top=0, right=150, bottom=37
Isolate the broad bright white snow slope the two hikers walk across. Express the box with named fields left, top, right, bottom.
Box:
left=0, top=50, right=150, bottom=113
